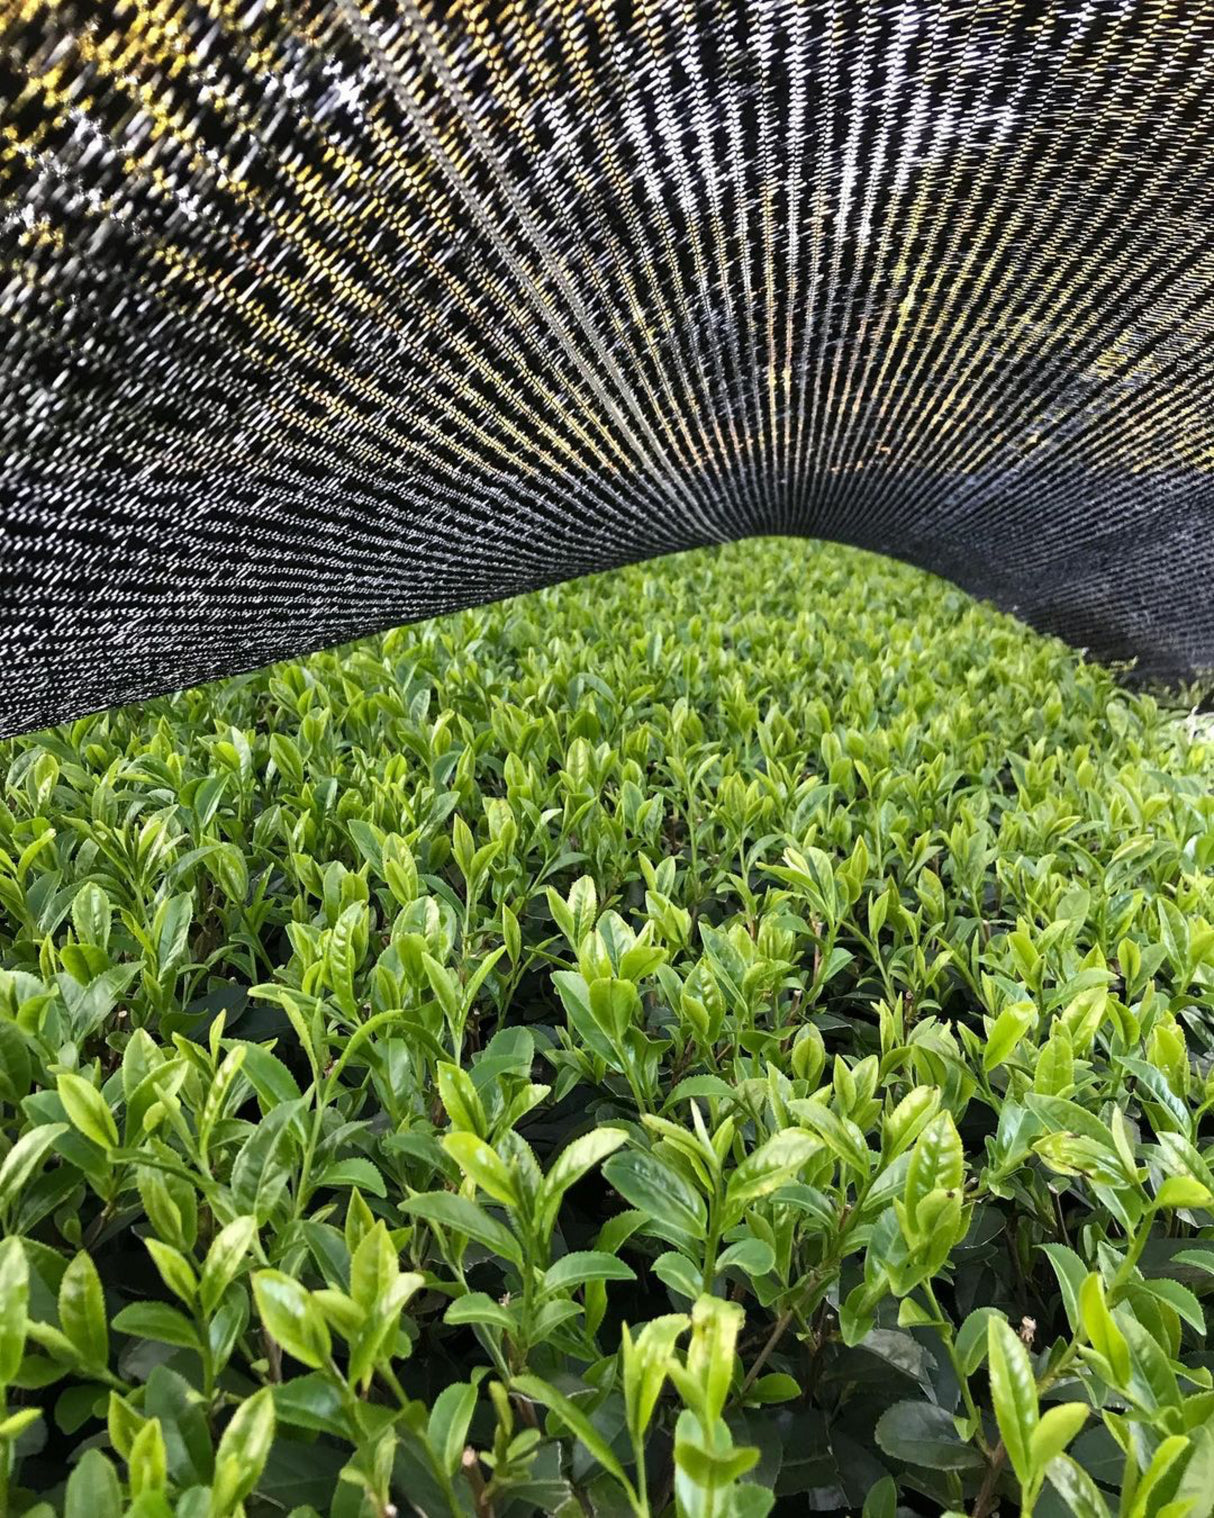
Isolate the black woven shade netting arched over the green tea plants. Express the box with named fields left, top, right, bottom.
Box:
left=0, top=0, right=1214, bottom=732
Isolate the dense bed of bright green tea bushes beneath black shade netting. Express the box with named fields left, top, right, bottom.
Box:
left=0, top=540, right=1214, bottom=1518
